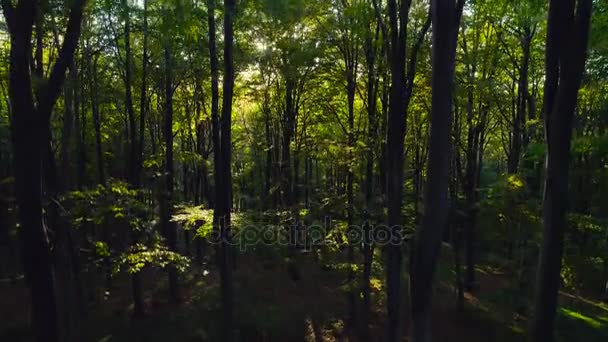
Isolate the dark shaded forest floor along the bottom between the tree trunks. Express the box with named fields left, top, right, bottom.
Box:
left=0, top=243, right=608, bottom=342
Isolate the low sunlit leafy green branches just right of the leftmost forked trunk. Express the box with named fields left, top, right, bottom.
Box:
left=62, top=180, right=189, bottom=275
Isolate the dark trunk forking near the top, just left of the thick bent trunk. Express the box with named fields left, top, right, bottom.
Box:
left=373, top=0, right=430, bottom=341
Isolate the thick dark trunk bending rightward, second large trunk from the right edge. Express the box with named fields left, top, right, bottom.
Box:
left=411, top=0, right=464, bottom=342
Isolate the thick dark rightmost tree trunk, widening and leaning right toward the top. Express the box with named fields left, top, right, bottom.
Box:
left=532, top=0, right=592, bottom=341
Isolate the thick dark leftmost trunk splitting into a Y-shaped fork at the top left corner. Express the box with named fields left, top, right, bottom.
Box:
left=2, top=0, right=85, bottom=342
